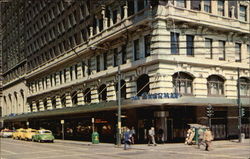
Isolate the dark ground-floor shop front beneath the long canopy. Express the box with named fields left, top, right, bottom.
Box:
left=4, top=106, right=250, bottom=143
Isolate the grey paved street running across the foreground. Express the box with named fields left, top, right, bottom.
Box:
left=0, top=139, right=250, bottom=159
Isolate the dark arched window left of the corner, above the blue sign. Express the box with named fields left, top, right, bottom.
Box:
left=136, top=74, right=149, bottom=96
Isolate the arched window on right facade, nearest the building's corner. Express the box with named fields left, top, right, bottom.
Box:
left=173, top=72, right=193, bottom=95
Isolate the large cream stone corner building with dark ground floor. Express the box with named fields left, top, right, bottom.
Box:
left=1, top=0, right=250, bottom=142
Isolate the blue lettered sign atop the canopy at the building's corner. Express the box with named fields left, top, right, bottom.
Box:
left=131, top=93, right=181, bottom=100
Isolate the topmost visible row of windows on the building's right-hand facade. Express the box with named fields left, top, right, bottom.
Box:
left=175, top=0, right=247, bottom=21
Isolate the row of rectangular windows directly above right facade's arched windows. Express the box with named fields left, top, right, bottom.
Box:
left=171, top=32, right=250, bottom=62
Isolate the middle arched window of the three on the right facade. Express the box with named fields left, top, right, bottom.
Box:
left=207, top=75, right=224, bottom=95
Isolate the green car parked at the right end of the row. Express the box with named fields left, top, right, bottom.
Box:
left=32, top=129, right=55, bottom=142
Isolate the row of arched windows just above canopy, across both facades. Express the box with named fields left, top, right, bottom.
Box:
left=30, top=72, right=250, bottom=110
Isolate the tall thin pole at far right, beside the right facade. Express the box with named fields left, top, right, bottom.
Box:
left=237, top=67, right=242, bottom=142
